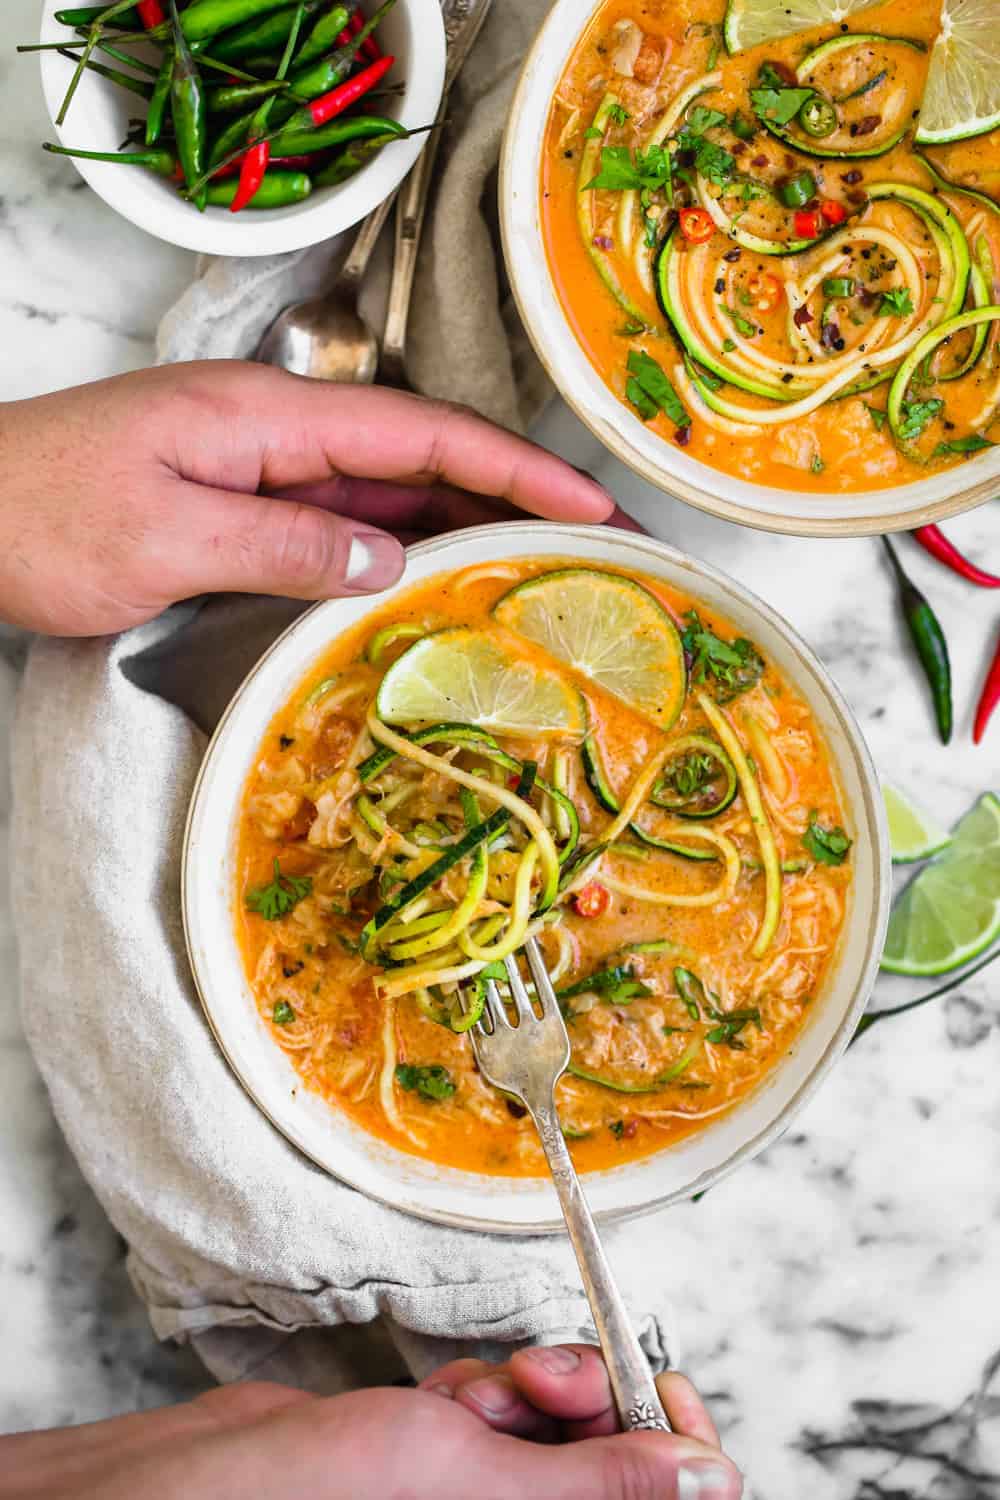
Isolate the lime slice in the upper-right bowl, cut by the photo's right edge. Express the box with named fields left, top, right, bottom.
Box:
left=915, top=0, right=1000, bottom=146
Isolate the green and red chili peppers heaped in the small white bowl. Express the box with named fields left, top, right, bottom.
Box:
left=18, top=0, right=411, bottom=213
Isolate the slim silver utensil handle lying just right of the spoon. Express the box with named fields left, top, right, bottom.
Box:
left=379, top=0, right=492, bottom=386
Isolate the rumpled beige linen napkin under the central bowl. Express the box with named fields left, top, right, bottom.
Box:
left=7, top=0, right=676, bottom=1391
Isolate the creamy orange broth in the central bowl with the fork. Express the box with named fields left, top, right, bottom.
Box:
left=234, top=558, right=850, bottom=1176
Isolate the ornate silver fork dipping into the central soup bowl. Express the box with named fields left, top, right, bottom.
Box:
left=469, top=938, right=670, bottom=1433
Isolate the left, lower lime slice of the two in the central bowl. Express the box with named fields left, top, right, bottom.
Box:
left=376, top=630, right=586, bottom=735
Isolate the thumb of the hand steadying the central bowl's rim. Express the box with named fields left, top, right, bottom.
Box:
left=169, top=485, right=405, bottom=599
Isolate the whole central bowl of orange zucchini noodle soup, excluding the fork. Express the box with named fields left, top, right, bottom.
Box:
left=184, top=522, right=889, bottom=1232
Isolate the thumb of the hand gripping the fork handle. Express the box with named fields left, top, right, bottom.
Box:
left=470, top=1433, right=744, bottom=1500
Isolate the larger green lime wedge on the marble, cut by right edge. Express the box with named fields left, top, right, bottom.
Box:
left=882, top=792, right=1000, bottom=975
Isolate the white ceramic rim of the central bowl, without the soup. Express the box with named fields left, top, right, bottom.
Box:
left=183, top=522, right=891, bottom=1233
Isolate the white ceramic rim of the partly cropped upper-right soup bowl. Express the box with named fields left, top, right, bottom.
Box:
left=499, top=0, right=1000, bottom=536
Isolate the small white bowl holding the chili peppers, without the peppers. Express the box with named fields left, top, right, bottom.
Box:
left=39, top=0, right=445, bottom=255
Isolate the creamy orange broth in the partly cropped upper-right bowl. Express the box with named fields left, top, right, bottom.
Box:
left=541, top=0, right=1000, bottom=491
